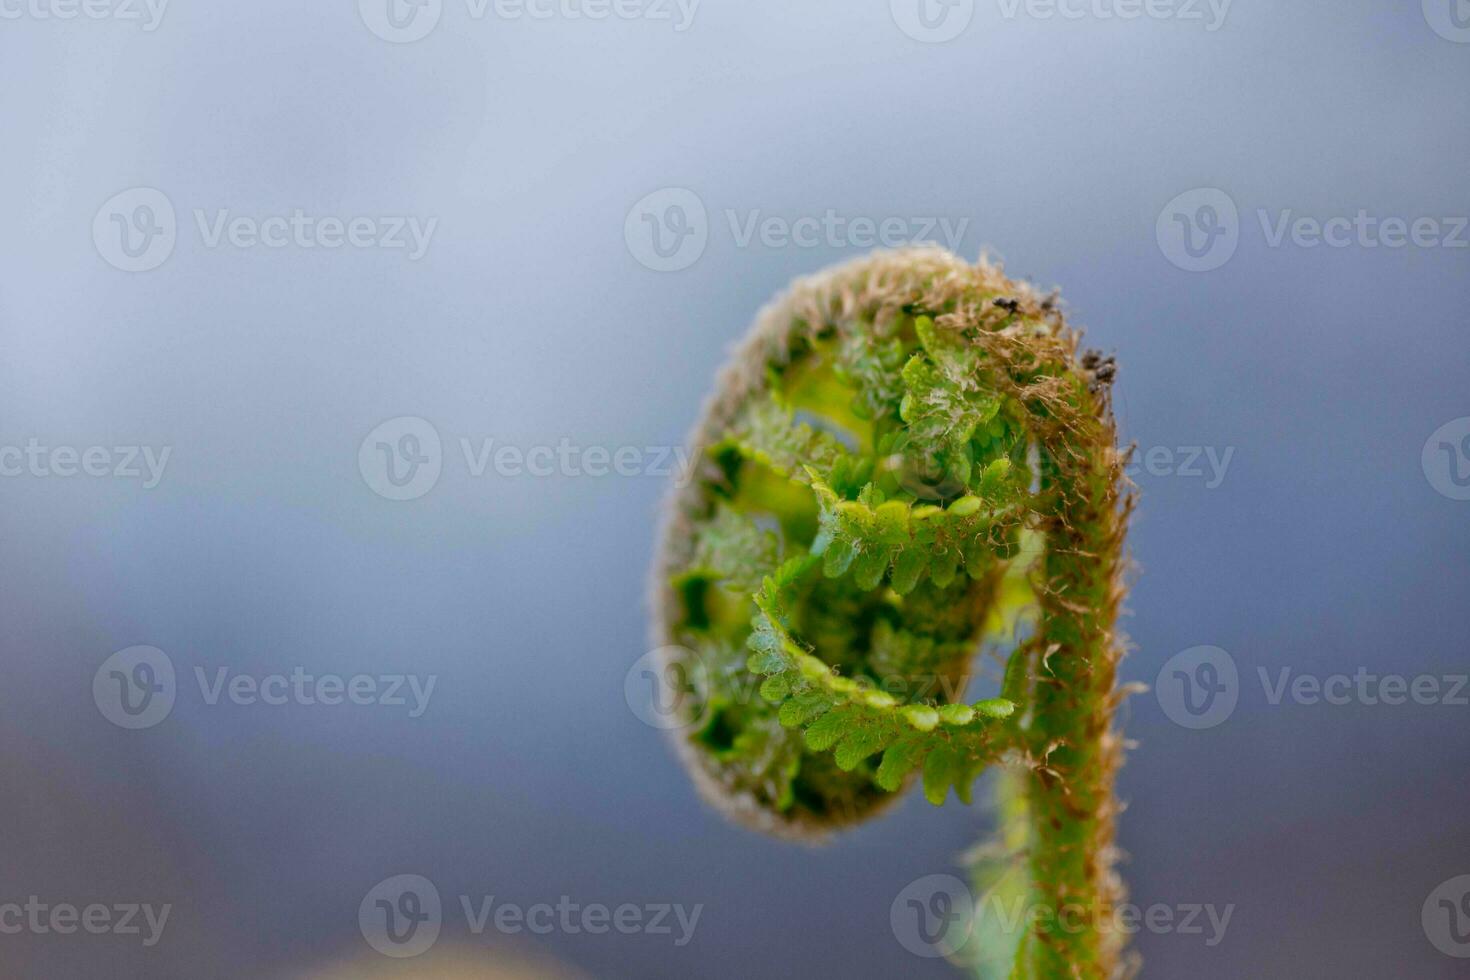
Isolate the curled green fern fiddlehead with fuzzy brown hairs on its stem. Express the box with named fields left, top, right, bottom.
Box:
left=654, top=248, right=1132, bottom=979
